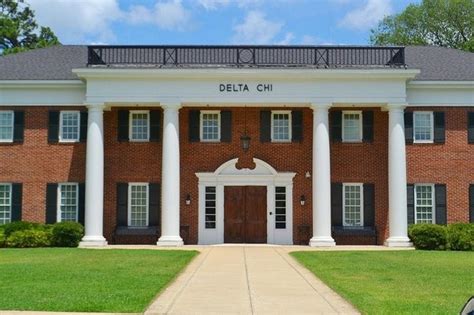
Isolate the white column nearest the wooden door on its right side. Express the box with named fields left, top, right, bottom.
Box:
left=309, top=105, right=336, bottom=246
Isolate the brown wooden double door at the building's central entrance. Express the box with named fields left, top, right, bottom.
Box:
left=224, top=186, right=267, bottom=243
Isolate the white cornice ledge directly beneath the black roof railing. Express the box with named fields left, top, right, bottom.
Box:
left=72, top=68, right=420, bottom=80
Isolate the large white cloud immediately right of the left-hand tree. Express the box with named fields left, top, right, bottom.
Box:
left=28, top=0, right=122, bottom=43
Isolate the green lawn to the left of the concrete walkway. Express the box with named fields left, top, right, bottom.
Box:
left=0, top=248, right=197, bottom=312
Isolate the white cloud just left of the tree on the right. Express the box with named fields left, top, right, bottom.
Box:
left=339, top=0, right=392, bottom=30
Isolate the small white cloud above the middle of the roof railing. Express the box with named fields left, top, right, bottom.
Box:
left=232, top=11, right=283, bottom=44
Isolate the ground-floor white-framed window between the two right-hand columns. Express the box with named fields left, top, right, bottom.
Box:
left=343, top=184, right=364, bottom=226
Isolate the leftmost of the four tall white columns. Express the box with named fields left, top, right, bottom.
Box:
left=79, top=104, right=107, bottom=247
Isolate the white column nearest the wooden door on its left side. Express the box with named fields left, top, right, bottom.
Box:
left=157, top=104, right=183, bottom=246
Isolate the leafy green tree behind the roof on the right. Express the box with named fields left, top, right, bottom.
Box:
left=370, top=0, right=474, bottom=52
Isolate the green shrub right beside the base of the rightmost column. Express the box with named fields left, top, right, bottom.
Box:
left=408, top=224, right=446, bottom=250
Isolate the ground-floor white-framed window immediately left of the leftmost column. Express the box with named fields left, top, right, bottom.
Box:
left=57, top=183, right=79, bottom=222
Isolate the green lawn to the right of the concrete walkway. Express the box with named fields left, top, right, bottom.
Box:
left=291, top=250, right=474, bottom=314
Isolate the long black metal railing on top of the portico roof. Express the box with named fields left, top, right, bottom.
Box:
left=88, top=45, right=405, bottom=68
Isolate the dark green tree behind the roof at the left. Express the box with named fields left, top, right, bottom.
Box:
left=0, top=0, right=60, bottom=55
